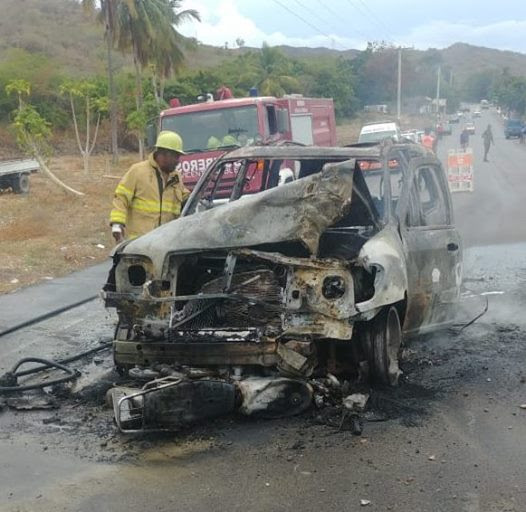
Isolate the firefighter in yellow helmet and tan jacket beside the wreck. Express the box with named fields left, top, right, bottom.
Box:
left=110, top=131, right=190, bottom=243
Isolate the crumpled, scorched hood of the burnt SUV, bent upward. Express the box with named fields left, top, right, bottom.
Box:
left=120, top=160, right=355, bottom=275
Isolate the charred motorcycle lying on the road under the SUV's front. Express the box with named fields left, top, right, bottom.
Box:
left=110, top=377, right=313, bottom=434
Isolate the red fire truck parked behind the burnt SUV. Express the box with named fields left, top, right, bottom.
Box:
left=160, top=95, right=336, bottom=189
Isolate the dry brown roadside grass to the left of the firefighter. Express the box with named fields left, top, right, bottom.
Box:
left=0, top=155, right=137, bottom=293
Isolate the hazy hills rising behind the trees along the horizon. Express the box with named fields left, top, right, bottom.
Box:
left=0, top=0, right=526, bottom=83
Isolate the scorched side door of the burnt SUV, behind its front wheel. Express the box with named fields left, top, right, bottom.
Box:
left=400, top=159, right=462, bottom=334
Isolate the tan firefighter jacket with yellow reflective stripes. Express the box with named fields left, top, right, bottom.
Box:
left=110, top=154, right=190, bottom=239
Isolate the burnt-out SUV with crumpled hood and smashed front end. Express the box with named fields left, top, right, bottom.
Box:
left=103, top=144, right=462, bottom=432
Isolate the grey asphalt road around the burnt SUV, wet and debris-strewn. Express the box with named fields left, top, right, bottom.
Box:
left=0, top=109, right=526, bottom=512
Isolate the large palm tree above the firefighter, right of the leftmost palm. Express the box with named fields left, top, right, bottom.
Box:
left=114, top=0, right=200, bottom=155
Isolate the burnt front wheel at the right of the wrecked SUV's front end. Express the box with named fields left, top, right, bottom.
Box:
left=362, top=306, right=402, bottom=386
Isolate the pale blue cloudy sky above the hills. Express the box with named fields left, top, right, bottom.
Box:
left=178, top=0, right=526, bottom=53
